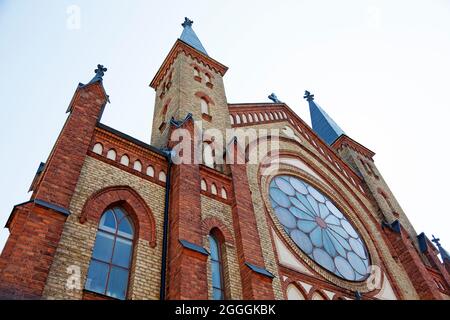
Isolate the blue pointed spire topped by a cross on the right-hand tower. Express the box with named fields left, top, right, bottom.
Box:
left=303, top=91, right=345, bottom=145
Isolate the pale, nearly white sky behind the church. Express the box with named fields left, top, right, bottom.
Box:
left=0, top=0, right=450, bottom=255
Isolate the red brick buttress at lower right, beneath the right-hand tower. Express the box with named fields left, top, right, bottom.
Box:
left=384, top=226, right=442, bottom=300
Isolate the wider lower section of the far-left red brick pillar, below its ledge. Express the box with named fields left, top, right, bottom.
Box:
left=0, top=203, right=66, bottom=299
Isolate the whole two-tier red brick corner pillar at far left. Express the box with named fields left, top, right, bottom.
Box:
left=0, top=82, right=106, bottom=299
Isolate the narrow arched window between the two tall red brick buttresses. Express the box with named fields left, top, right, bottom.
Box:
left=209, top=233, right=225, bottom=300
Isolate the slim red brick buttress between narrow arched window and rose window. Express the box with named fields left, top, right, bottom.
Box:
left=230, top=142, right=275, bottom=300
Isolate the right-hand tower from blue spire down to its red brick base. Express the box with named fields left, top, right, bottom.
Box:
left=304, top=91, right=448, bottom=299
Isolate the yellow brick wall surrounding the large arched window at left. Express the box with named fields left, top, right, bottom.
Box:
left=43, top=157, right=165, bottom=299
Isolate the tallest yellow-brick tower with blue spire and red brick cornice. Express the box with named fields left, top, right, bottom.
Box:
left=150, top=18, right=231, bottom=147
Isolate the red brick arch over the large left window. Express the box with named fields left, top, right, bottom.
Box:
left=79, top=186, right=156, bottom=248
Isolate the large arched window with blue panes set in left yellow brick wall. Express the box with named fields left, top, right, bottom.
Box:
left=85, top=207, right=134, bottom=300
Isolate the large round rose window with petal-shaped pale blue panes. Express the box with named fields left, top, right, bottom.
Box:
left=269, top=175, right=369, bottom=281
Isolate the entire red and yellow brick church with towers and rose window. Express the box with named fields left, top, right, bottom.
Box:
left=0, top=18, right=450, bottom=300
